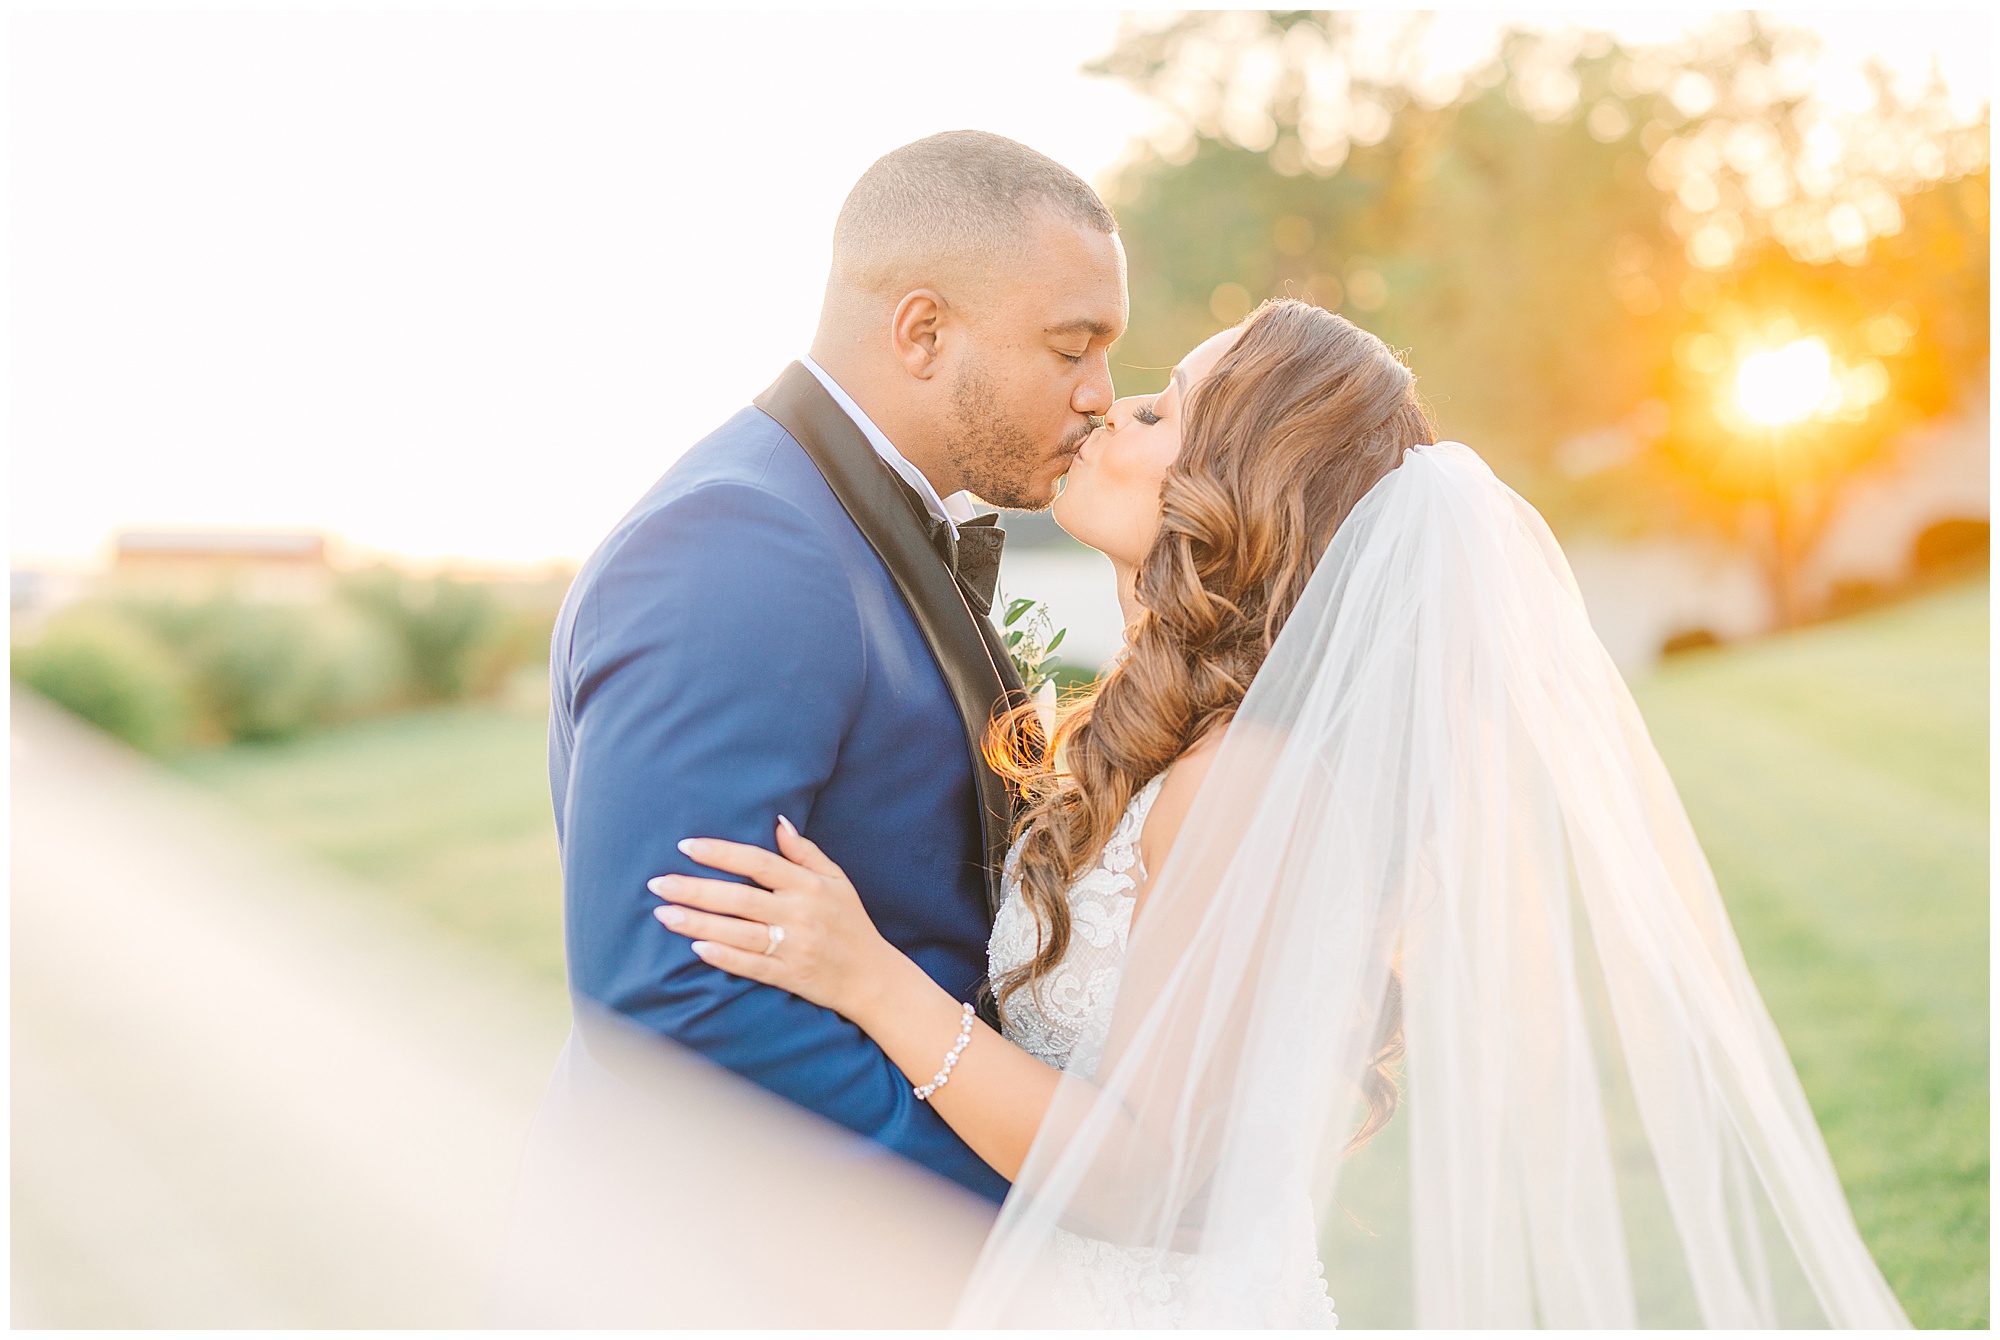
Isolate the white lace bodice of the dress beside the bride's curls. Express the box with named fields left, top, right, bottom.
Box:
left=986, top=774, right=1164, bottom=1066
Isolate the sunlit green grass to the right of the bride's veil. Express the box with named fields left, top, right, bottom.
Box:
left=1636, top=582, right=1988, bottom=1326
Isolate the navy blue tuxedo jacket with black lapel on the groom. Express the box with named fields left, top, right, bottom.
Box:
left=548, top=364, right=1020, bottom=1200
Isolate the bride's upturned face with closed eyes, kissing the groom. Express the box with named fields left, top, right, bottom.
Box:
left=1052, top=330, right=1240, bottom=568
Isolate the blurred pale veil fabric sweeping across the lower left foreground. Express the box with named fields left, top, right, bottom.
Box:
left=12, top=696, right=990, bottom=1328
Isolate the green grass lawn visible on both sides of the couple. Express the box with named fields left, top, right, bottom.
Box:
left=182, top=582, right=1988, bottom=1326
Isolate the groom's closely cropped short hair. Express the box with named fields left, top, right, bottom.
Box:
left=834, top=130, right=1118, bottom=298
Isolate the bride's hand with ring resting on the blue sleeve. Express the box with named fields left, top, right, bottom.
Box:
left=648, top=816, right=908, bottom=1026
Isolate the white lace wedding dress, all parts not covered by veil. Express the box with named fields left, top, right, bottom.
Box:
left=986, top=774, right=1340, bottom=1330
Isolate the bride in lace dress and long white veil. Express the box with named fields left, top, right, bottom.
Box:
left=654, top=302, right=1908, bottom=1328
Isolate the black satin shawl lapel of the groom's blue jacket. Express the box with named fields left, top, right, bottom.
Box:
left=754, top=362, right=1024, bottom=920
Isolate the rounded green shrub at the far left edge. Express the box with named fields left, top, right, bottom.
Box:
left=12, top=606, right=192, bottom=754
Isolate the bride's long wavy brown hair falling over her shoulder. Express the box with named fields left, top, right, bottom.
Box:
left=988, top=300, right=1436, bottom=1142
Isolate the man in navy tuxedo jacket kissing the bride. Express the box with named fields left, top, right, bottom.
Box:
left=548, top=130, right=1126, bottom=1200
